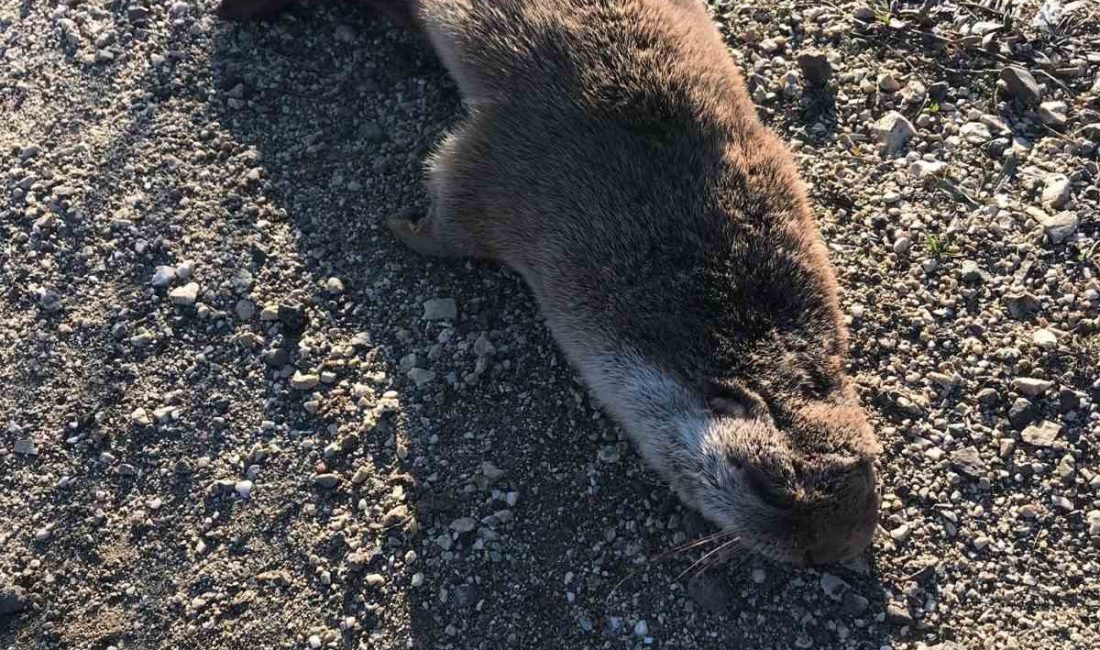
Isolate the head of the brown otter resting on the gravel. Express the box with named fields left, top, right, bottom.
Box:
left=685, top=378, right=881, bottom=565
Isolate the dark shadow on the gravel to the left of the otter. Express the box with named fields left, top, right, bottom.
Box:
left=204, top=10, right=890, bottom=649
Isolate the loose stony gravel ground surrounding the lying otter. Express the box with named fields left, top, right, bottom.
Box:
left=0, top=0, right=1100, bottom=650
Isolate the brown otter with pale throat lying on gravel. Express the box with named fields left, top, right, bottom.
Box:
left=220, top=0, right=881, bottom=565
